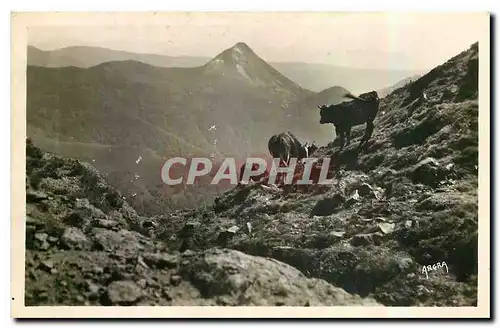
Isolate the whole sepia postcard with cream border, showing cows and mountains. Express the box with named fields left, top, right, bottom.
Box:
left=11, top=11, right=491, bottom=317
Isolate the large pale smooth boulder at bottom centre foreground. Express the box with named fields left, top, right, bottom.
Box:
left=181, top=249, right=377, bottom=306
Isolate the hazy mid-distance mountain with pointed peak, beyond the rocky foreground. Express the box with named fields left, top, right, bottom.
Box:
left=27, top=43, right=332, bottom=215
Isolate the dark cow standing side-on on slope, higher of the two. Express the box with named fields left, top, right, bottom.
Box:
left=318, top=91, right=380, bottom=150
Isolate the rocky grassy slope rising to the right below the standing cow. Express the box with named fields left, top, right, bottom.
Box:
left=148, top=43, right=479, bottom=306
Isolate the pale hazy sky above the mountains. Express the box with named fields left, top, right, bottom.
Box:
left=28, top=12, right=488, bottom=70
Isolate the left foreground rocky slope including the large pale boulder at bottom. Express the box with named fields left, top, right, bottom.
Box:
left=25, top=140, right=377, bottom=306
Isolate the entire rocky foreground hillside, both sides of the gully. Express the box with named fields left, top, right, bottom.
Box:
left=26, top=44, right=478, bottom=306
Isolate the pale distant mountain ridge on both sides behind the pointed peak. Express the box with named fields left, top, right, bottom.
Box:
left=28, top=46, right=424, bottom=93
